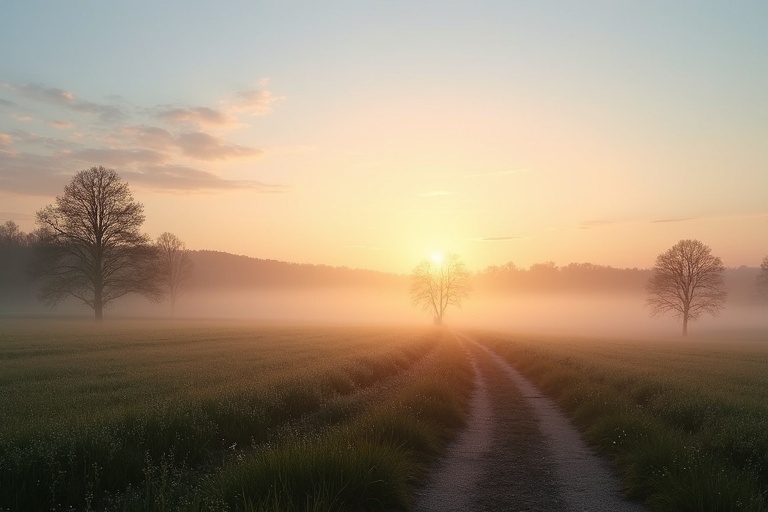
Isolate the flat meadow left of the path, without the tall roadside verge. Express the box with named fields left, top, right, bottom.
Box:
left=0, top=320, right=462, bottom=510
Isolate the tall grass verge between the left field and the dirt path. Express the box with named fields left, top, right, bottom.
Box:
left=215, top=337, right=473, bottom=511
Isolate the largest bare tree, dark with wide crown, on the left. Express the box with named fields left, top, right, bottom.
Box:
left=35, top=167, right=162, bottom=321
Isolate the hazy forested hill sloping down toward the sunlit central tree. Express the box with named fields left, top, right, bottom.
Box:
left=189, top=251, right=408, bottom=289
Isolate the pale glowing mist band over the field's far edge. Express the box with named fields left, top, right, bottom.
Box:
left=42, top=287, right=768, bottom=339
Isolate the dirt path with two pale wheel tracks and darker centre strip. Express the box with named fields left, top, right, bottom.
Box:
left=415, top=335, right=643, bottom=512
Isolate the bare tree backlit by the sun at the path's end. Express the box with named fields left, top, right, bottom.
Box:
left=411, top=254, right=470, bottom=325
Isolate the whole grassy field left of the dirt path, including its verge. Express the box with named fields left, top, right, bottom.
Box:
left=0, top=320, right=472, bottom=510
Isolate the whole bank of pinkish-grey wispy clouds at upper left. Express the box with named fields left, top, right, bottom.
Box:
left=0, top=81, right=288, bottom=195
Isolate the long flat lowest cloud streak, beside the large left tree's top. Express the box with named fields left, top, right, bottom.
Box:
left=121, top=165, right=287, bottom=193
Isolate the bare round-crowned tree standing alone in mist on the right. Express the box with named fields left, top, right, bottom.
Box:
left=646, top=240, right=727, bottom=336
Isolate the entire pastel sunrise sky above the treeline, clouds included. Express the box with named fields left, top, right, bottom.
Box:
left=0, top=0, right=768, bottom=273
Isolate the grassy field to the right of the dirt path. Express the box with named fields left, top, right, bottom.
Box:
left=476, top=333, right=768, bottom=512
